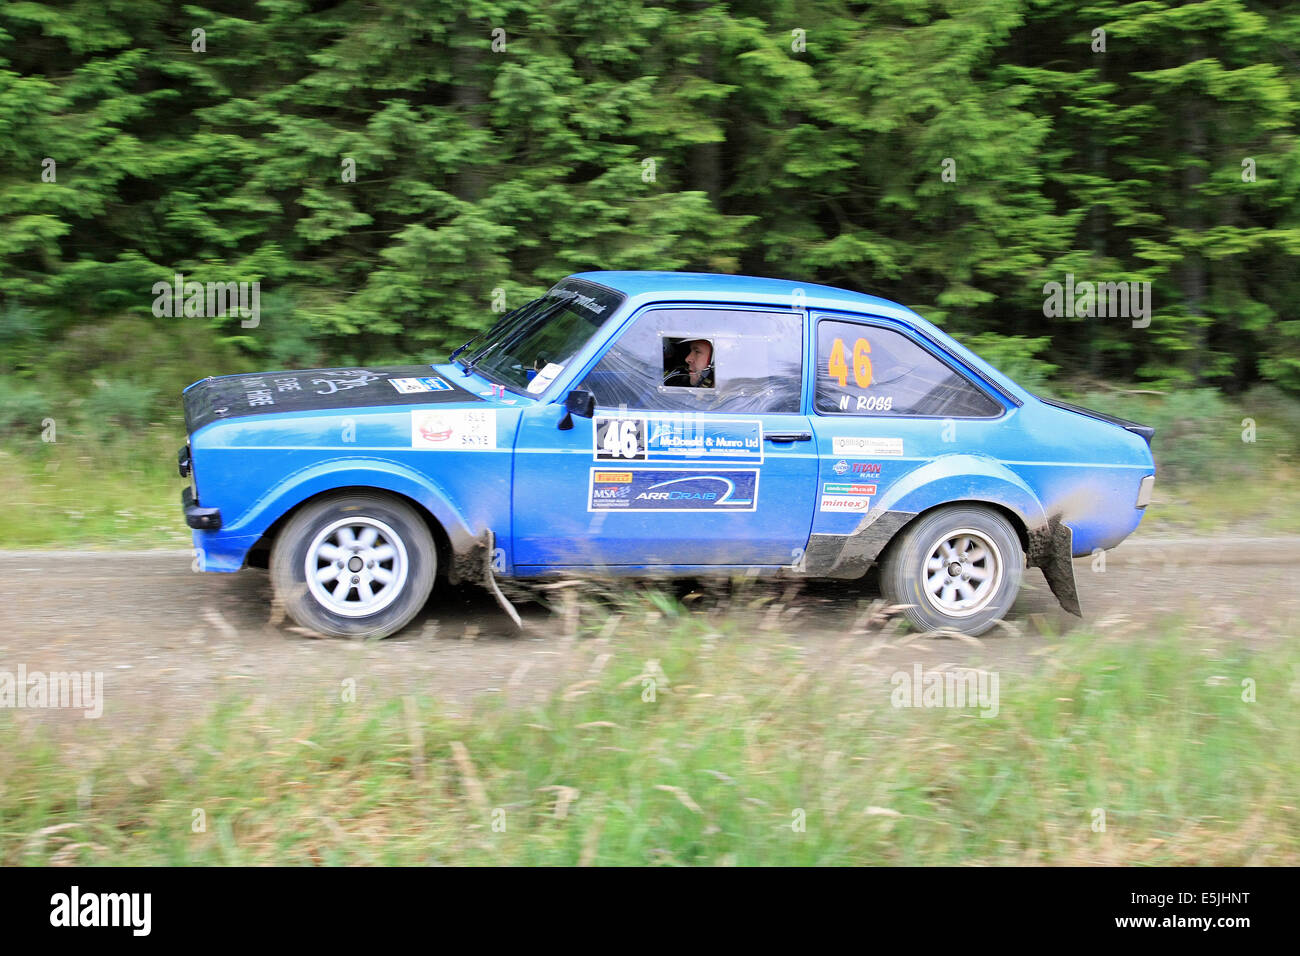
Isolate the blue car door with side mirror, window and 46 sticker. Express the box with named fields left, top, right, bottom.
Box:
left=511, top=303, right=818, bottom=575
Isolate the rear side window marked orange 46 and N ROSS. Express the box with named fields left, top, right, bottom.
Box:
left=816, top=319, right=1002, bottom=419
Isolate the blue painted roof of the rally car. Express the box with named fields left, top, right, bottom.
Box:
left=569, top=272, right=920, bottom=321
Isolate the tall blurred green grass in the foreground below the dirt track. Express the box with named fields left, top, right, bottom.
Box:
left=0, top=598, right=1300, bottom=865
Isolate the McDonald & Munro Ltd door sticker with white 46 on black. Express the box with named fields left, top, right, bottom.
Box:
left=593, top=415, right=763, bottom=464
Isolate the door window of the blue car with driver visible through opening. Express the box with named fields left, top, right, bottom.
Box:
left=582, top=307, right=803, bottom=414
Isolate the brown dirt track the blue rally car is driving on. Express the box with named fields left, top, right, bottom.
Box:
left=0, top=538, right=1300, bottom=736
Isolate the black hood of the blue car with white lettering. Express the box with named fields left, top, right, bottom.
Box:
left=185, top=365, right=486, bottom=434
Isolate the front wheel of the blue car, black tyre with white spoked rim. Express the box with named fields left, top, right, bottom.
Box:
left=270, top=492, right=438, bottom=637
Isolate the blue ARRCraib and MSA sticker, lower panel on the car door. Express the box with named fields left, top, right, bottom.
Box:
left=586, top=468, right=758, bottom=511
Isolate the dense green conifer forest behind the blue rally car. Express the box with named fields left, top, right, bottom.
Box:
left=0, top=0, right=1300, bottom=546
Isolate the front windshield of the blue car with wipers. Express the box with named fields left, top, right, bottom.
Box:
left=462, top=280, right=623, bottom=394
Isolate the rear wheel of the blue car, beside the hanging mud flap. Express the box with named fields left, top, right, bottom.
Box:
left=880, top=505, right=1024, bottom=637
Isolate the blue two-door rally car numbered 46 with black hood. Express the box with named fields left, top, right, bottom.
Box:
left=179, top=272, right=1156, bottom=637
